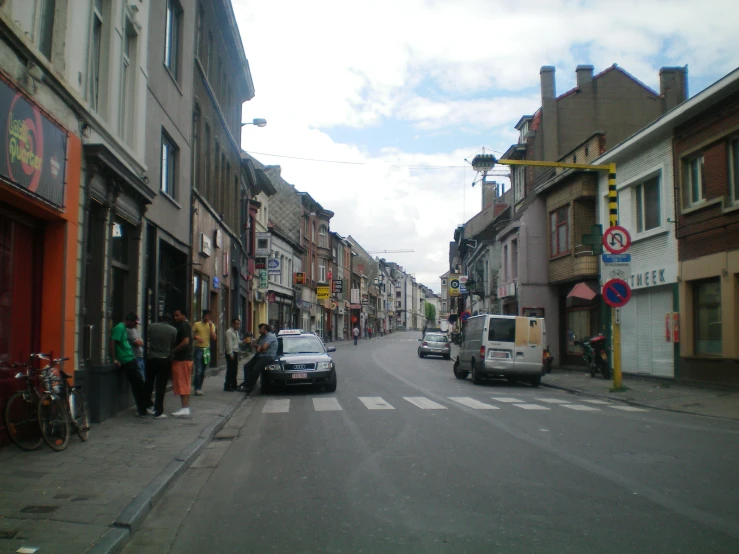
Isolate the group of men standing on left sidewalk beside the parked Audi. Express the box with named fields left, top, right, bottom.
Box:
left=110, top=310, right=277, bottom=419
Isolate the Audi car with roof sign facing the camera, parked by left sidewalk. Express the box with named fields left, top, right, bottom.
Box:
left=261, top=329, right=337, bottom=394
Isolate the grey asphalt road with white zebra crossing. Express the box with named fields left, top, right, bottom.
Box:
left=126, top=333, right=739, bottom=554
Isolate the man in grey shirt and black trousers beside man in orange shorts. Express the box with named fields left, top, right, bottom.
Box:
left=146, top=313, right=177, bottom=419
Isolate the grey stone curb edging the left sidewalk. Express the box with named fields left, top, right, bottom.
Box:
left=85, top=390, right=247, bottom=554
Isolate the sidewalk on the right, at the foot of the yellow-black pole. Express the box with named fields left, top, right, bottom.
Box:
left=541, top=369, right=739, bottom=420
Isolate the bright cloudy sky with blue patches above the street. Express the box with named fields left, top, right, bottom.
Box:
left=232, top=0, right=739, bottom=292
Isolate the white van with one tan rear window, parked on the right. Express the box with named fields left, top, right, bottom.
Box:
left=454, top=315, right=546, bottom=387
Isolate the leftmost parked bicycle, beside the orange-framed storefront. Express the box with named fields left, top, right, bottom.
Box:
left=5, top=354, right=50, bottom=450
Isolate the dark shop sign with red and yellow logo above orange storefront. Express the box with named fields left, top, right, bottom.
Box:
left=0, top=79, right=67, bottom=208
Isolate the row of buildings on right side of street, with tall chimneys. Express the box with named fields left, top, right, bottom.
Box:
left=450, top=66, right=739, bottom=384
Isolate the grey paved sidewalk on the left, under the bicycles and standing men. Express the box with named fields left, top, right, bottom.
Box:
left=0, top=363, right=246, bottom=554
